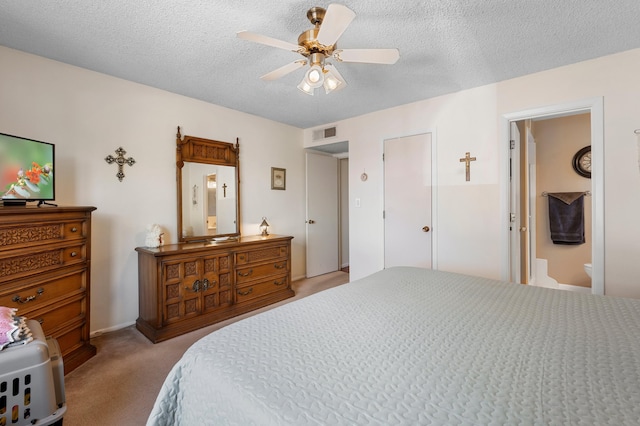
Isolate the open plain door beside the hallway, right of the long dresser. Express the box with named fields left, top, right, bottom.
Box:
left=306, top=152, right=340, bottom=277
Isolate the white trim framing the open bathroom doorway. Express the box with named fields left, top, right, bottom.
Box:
left=500, top=97, right=605, bottom=295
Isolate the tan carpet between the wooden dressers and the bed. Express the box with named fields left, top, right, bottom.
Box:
left=63, top=271, right=349, bottom=426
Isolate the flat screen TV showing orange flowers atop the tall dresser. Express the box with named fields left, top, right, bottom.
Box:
left=0, top=133, right=56, bottom=206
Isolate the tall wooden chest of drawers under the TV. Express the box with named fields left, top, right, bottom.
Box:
left=0, top=206, right=96, bottom=374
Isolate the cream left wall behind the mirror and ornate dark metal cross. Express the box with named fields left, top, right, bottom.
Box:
left=0, top=46, right=305, bottom=332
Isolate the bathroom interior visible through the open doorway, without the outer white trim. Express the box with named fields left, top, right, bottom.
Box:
left=511, top=112, right=593, bottom=292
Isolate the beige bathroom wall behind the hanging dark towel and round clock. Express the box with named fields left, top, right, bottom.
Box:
left=532, top=114, right=592, bottom=287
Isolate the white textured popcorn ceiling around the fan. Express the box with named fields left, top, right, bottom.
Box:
left=0, top=0, right=640, bottom=128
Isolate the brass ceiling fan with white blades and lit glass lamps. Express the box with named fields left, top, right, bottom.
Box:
left=237, top=3, right=400, bottom=95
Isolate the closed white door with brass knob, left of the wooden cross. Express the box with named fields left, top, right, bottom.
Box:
left=384, top=133, right=432, bottom=268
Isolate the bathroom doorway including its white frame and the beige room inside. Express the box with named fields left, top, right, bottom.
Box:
left=502, top=98, right=604, bottom=294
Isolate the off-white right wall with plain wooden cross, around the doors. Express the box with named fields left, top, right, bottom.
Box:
left=305, top=49, right=640, bottom=298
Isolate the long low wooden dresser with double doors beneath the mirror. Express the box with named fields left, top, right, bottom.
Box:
left=136, top=235, right=295, bottom=343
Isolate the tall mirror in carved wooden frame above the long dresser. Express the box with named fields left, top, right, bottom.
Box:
left=176, top=127, right=240, bottom=242
